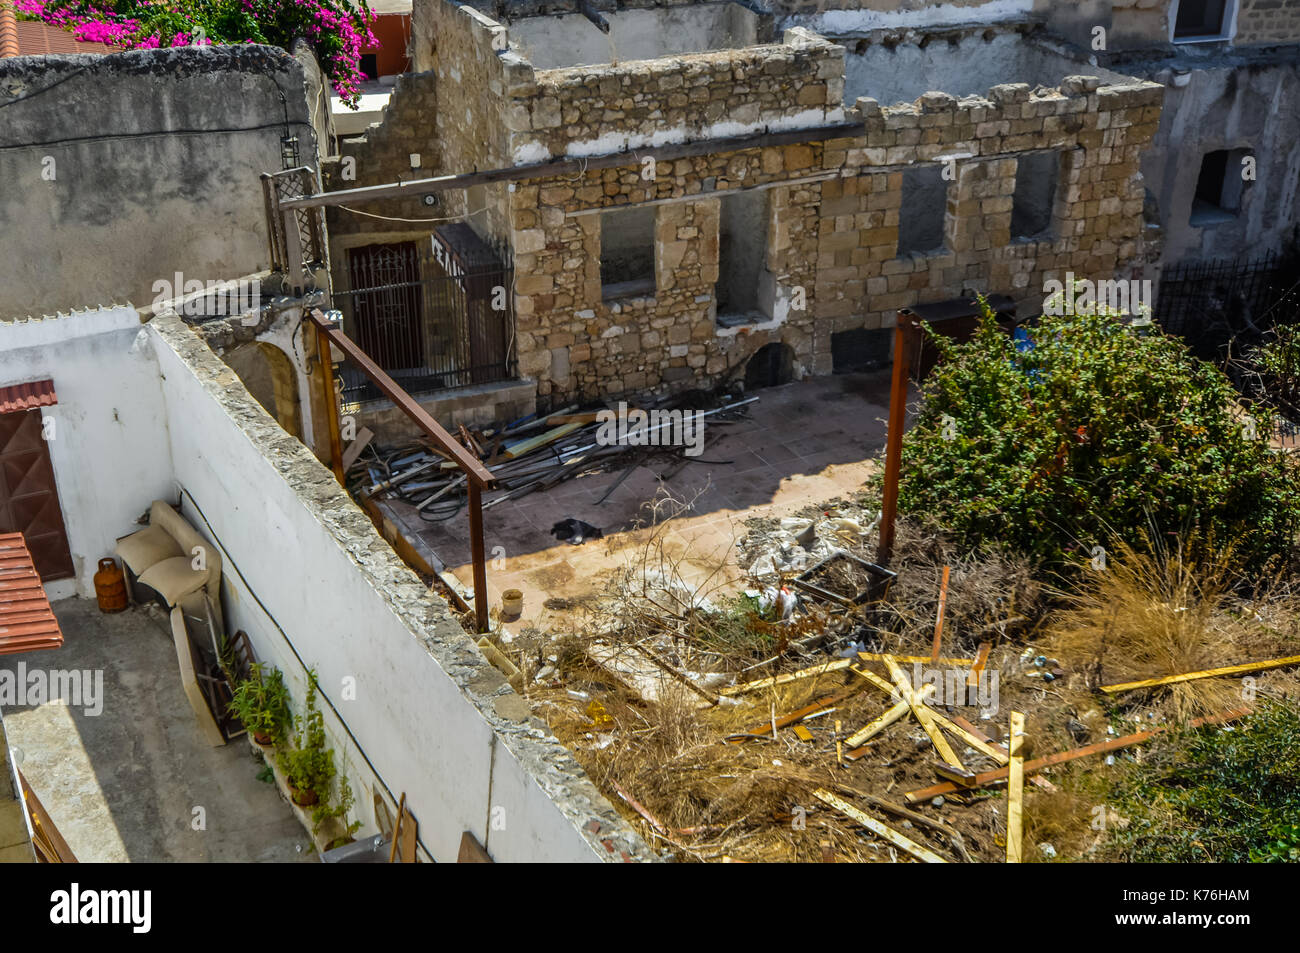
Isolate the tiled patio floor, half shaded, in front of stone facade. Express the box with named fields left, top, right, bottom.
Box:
left=391, top=372, right=909, bottom=623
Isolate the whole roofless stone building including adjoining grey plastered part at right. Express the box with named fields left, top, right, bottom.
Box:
left=309, top=0, right=1300, bottom=426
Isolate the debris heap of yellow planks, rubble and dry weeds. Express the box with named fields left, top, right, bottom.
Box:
left=493, top=499, right=1300, bottom=863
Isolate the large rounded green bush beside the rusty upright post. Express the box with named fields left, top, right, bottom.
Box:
left=898, top=307, right=1300, bottom=566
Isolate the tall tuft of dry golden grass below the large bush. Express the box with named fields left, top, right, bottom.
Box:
left=1047, top=537, right=1251, bottom=720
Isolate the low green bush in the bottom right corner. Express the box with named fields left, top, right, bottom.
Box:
left=1108, top=702, right=1300, bottom=863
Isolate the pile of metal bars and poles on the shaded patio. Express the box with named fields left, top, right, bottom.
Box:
left=347, top=394, right=758, bottom=523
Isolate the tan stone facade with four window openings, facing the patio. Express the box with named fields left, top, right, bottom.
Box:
left=512, top=77, right=1161, bottom=402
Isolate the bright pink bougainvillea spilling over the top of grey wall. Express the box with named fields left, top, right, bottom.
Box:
left=14, top=0, right=378, bottom=105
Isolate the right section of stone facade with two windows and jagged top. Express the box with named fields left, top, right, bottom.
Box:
left=814, top=77, right=1162, bottom=335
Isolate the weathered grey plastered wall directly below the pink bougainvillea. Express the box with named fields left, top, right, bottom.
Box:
left=0, top=44, right=328, bottom=317
